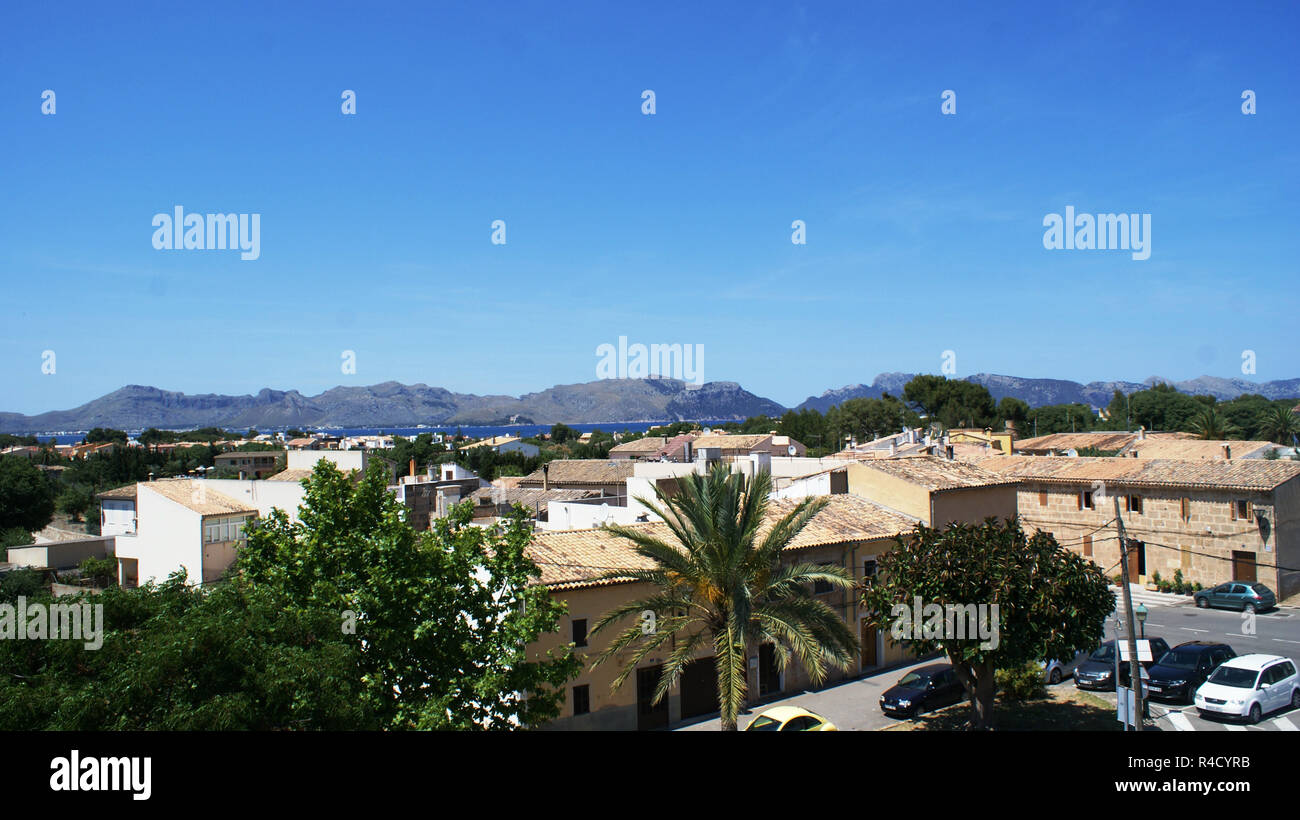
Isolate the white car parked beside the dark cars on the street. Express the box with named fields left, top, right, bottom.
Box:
left=1196, top=655, right=1300, bottom=724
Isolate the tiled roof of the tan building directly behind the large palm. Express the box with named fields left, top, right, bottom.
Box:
left=528, top=495, right=915, bottom=590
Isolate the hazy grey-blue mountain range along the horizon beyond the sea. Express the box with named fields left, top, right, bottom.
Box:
left=0, top=373, right=1300, bottom=433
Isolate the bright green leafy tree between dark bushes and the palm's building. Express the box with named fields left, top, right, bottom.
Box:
left=239, top=461, right=580, bottom=729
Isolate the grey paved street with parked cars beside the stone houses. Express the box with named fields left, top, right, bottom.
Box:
left=677, top=596, right=1300, bottom=732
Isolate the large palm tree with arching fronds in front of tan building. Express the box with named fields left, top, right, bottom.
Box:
left=592, top=464, right=858, bottom=732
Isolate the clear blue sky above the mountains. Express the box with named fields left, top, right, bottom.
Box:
left=0, top=3, right=1300, bottom=413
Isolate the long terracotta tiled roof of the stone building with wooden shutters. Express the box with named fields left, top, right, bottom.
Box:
left=978, top=456, right=1300, bottom=491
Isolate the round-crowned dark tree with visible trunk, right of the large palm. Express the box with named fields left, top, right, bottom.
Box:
left=863, top=519, right=1115, bottom=729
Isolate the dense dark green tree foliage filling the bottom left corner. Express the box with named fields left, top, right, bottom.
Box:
left=0, top=573, right=371, bottom=732
